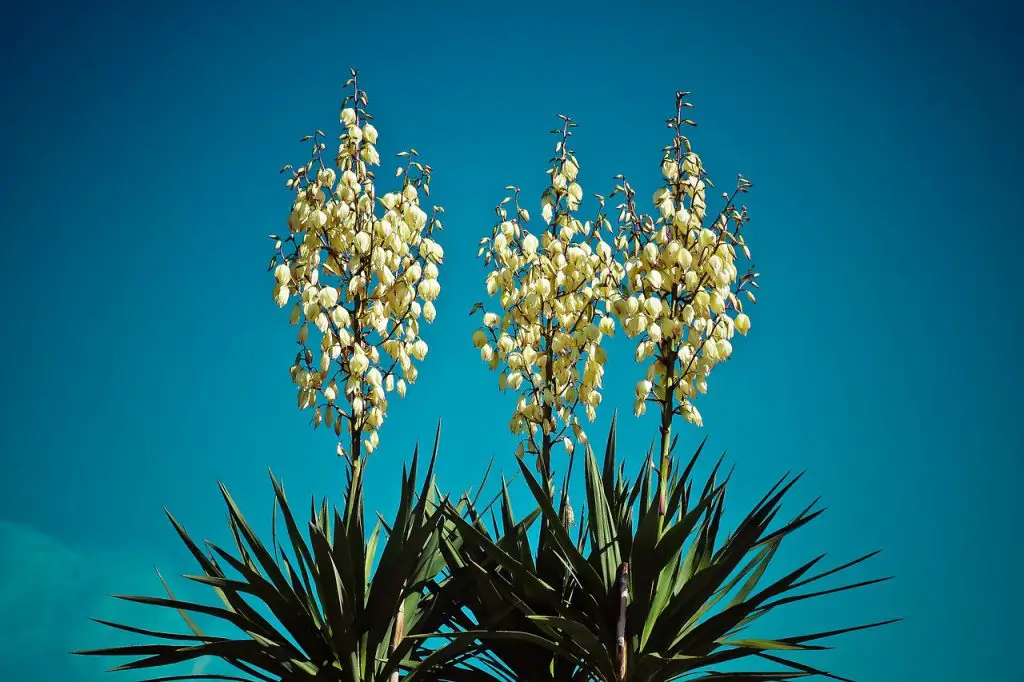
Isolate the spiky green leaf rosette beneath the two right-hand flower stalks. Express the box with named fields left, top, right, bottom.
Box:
left=425, top=413, right=890, bottom=682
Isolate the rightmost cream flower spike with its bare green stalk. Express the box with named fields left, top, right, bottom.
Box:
left=612, top=92, right=757, bottom=514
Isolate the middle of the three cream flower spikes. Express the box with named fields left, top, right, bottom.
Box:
left=473, top=116, right=622, bottom=483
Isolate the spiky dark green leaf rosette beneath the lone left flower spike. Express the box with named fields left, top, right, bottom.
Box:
left=77, top=432, right=468, bottom=682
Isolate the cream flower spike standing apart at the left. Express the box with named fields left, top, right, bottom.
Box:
left=270, top=71, right=443, bottom=463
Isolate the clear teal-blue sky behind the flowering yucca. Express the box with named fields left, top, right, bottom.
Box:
left=0, top=0, right=1024, bottom=682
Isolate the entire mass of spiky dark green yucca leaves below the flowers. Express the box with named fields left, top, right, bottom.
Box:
left=80, top=422, right=885, bottom=682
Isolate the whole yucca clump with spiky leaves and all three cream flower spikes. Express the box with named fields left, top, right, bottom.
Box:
left=70, top=71, right=897, bottom=682
